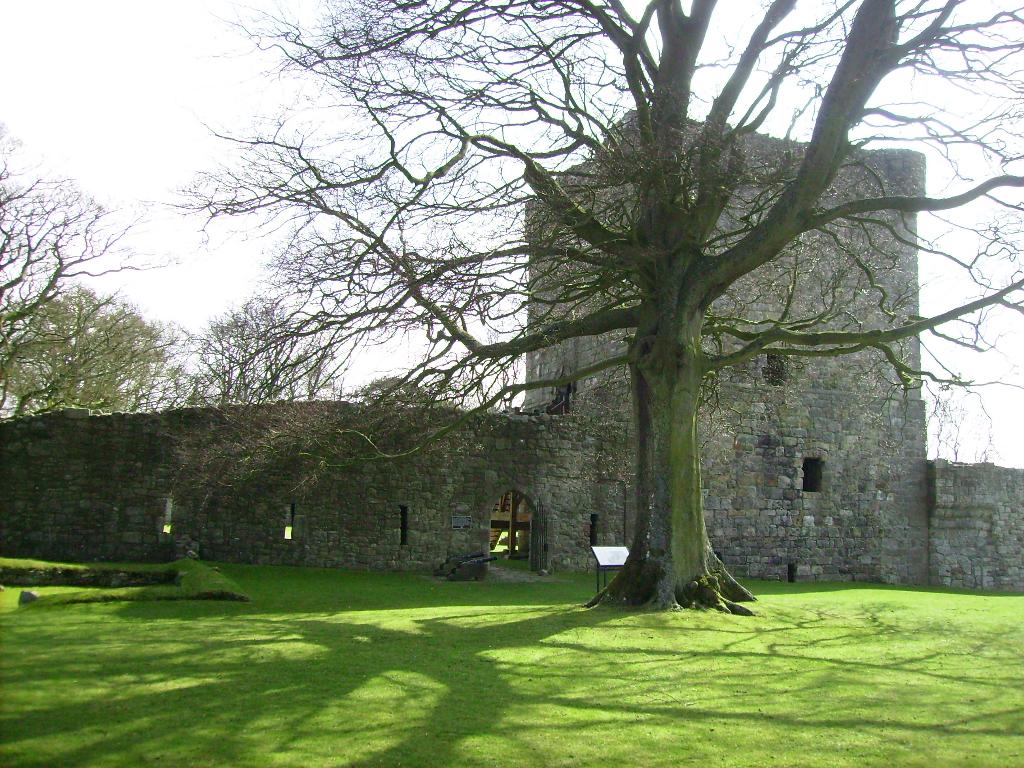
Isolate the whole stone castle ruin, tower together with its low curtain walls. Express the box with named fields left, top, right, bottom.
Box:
left=0, top=132, right=1024, bottom=591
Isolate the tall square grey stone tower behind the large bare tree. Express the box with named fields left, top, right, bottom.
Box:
left=527, top=136, right=929, bottom=584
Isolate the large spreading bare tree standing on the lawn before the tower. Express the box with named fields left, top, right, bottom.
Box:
left=197, top=0, right=1024, bottom=612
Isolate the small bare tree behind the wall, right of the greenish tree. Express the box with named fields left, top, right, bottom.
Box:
left=189, top=299, right=350, bottom=407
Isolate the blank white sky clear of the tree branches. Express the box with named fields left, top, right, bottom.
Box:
left=0, top=0, right=1024, bottom=466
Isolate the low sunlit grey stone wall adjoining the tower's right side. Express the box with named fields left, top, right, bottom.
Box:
left=929, top=461, right=1024, bottom=592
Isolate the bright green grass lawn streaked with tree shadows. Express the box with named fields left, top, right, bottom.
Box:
left=0, top=565, right=1024, bottom=768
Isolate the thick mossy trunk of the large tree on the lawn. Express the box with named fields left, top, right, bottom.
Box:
left=591, top=321, right=754, bottom=614
